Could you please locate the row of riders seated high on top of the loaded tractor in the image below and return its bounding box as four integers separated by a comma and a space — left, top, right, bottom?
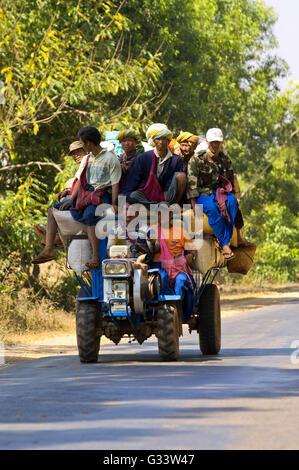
33, 124, 243, 269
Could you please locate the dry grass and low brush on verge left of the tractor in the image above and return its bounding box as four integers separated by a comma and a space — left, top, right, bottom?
0, 262, 78, 343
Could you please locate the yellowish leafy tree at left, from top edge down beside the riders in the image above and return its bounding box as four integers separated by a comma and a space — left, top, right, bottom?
0, 0, 164, 288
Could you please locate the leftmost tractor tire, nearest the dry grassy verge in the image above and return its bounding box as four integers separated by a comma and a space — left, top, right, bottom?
76, 294, 101, 362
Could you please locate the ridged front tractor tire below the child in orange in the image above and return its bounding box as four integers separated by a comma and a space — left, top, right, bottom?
157, 305, 179, 361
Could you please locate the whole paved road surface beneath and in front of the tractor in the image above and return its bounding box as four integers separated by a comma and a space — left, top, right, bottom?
0, 301, 299, 450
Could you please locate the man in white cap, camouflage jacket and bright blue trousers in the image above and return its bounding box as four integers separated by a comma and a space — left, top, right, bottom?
187, 128, 239, 260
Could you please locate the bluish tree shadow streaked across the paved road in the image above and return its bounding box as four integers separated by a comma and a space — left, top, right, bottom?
0, 342, 299, 449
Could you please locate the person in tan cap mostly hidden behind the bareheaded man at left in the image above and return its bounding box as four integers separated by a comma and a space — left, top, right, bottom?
33, 140, 87, 246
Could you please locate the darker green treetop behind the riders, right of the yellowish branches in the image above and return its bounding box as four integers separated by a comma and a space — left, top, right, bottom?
124, 0, 288, 176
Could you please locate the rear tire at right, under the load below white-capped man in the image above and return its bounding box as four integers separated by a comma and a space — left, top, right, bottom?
198, 284, 221, 355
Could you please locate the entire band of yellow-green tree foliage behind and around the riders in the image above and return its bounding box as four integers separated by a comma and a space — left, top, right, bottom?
0, 0, 298, 288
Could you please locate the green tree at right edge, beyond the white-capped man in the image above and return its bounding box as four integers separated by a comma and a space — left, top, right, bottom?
242, 85, 299, 281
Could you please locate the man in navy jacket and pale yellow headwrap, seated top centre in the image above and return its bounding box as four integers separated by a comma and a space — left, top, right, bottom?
122, 123, 187, 205
